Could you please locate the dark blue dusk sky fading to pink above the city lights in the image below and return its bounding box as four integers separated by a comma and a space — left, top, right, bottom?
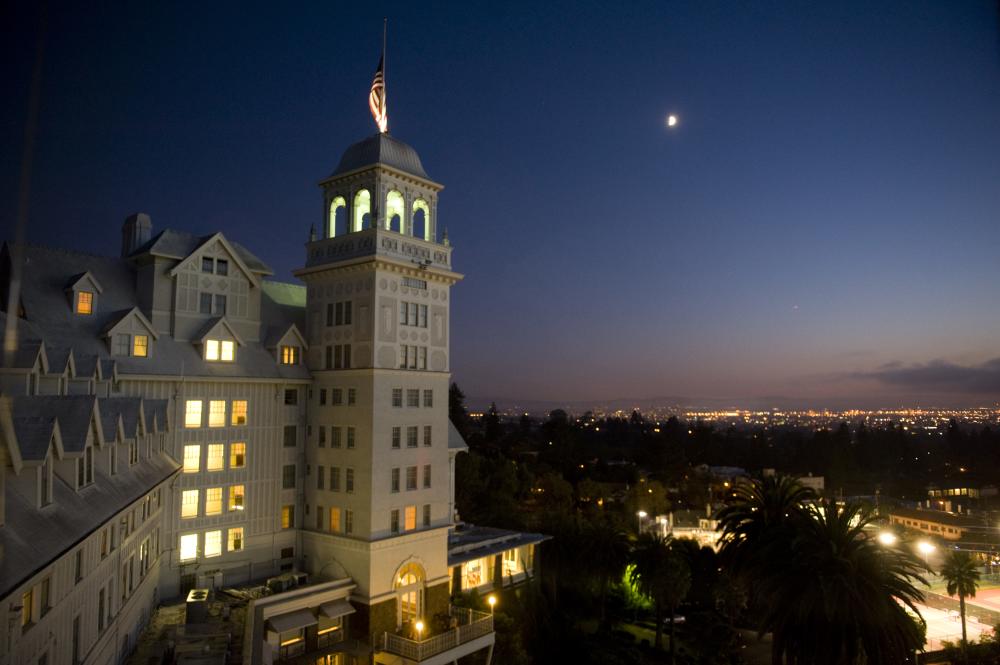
0, 0, 1000, 406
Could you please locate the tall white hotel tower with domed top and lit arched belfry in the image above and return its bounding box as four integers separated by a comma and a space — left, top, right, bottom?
295, 133, 462, 637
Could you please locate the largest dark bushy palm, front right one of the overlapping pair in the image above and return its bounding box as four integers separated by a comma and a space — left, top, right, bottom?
761, 504, 926, 665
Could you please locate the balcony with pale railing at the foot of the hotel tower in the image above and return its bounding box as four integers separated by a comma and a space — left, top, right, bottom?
375, 607, 494, 665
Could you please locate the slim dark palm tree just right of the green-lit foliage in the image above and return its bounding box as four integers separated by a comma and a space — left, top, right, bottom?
631, 533, 691, 663
